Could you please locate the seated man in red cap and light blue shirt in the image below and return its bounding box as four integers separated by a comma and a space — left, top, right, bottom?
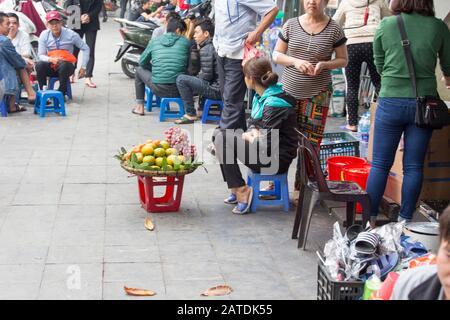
36, 11, 89, 96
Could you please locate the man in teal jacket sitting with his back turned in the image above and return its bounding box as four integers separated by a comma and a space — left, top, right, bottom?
132, 19, 191, 115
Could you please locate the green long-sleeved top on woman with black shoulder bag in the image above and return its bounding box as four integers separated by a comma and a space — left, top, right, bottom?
373, 13, 450, 98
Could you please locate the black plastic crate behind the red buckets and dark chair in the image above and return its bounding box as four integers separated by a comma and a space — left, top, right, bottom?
319, 132, 359, 172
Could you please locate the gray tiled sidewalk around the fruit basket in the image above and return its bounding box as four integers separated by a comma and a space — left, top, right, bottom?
0, 20, 334, 299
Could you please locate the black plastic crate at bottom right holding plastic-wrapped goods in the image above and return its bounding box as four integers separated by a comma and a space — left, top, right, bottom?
317, 255, 364, 300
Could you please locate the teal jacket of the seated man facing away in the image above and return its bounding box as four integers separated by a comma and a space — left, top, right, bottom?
139, 32, 191, 84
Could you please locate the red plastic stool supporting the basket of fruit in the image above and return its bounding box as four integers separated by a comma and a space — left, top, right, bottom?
138, 176, 184, 212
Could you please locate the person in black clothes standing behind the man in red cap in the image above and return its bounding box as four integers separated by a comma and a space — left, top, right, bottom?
65, 0, 103, 88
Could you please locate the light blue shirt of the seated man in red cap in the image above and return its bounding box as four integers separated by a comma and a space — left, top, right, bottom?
38, 28, 89, 68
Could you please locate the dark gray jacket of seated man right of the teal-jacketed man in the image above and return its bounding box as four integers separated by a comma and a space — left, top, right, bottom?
197, 39, 219, 88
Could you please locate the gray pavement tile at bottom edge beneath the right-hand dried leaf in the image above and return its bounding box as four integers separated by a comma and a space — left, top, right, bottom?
166, 280, 231, 300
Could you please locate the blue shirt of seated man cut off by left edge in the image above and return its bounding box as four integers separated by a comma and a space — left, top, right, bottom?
0, 35, 26, 95
